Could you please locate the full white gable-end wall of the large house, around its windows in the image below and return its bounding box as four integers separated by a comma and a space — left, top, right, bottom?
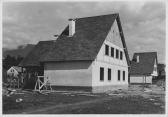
92, 19, 128, 86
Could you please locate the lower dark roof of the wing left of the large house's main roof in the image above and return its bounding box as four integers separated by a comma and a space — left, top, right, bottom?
19, 40, 54, 67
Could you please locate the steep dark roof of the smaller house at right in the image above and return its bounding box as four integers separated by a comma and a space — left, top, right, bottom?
130, 52, 157, 75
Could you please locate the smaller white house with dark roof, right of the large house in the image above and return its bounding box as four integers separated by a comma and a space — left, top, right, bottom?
130, 52, 158, 84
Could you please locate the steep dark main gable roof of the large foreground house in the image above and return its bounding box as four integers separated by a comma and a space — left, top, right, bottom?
19, 14, 129, 65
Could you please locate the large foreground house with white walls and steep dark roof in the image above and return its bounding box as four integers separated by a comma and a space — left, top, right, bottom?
20, 14, 129, 92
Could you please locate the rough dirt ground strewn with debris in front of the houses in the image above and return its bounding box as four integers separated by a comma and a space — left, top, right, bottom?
3, 85, 165, 114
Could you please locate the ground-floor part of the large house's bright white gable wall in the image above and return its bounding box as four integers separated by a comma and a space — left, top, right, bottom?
92, 61, 128, 86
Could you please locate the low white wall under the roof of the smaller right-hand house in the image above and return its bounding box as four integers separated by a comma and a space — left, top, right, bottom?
130, 75, 152, 84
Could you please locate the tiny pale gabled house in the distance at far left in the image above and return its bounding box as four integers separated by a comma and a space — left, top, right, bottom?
7, 66, 22, 78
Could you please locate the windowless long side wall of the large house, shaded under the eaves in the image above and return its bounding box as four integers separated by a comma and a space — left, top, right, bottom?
44, 61, 92, 86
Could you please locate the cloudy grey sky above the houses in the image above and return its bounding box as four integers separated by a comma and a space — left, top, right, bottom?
2, 1, 166, 63
